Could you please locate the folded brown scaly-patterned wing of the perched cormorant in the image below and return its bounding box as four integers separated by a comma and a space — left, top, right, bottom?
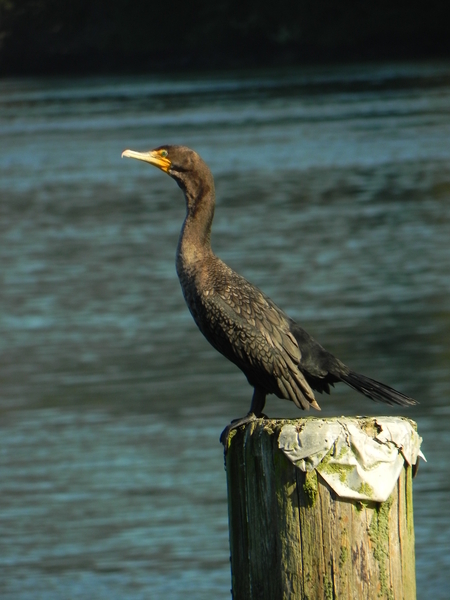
199, 278, 319, 409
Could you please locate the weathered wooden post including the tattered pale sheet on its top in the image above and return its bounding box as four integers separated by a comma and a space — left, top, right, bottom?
226, 417, 421, 600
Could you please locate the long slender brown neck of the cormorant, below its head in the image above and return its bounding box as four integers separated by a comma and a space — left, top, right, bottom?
177, 184, 215, 275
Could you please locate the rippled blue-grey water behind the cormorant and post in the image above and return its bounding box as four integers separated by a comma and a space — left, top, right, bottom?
0, 63, 450, 600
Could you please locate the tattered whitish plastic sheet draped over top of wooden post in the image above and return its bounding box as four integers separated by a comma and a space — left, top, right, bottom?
278, 417, 425, 502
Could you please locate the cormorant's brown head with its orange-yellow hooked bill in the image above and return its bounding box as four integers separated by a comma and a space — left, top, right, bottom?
122, 145, 213, 196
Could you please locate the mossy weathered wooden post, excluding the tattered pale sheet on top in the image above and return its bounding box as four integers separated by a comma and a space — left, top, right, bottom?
226, 418, 416, 600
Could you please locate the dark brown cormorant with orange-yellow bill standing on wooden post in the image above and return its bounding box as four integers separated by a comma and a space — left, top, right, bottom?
122, 145, 417, 448
